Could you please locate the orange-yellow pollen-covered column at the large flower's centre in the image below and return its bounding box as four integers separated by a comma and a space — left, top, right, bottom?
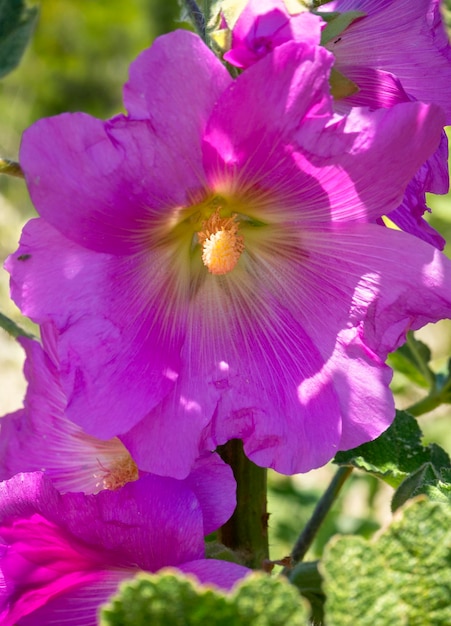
197, 208, 244, 274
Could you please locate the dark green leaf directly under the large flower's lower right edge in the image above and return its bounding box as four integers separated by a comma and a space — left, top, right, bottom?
334, 411, 451, 488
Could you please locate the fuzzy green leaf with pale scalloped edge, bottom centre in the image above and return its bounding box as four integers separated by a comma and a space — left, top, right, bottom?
100, 570, 308, 626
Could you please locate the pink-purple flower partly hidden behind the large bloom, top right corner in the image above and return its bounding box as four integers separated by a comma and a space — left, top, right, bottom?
320, 0, 451, 249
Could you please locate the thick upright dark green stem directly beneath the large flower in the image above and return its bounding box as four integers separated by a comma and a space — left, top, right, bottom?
218, 439, 269, 569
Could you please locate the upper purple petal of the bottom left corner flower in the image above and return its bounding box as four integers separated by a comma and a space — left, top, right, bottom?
0, 473, 204, 572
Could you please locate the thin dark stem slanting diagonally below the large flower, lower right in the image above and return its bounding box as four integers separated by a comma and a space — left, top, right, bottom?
282, 466, 353, 574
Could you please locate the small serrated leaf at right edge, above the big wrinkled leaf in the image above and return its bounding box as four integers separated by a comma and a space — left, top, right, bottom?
392, 462, 451, 511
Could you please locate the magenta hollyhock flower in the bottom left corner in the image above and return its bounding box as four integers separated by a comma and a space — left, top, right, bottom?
0, 472, 249, 626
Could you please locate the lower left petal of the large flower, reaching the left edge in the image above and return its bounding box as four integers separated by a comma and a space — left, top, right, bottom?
6, 219, 184, 439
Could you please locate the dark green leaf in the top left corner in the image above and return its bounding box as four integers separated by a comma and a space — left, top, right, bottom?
0, 0, 38, 78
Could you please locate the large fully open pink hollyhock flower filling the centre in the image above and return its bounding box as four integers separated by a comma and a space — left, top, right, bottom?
7, 31, 451, 478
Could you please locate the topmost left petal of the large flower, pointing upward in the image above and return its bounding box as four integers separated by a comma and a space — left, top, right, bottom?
124, 30, 232, 131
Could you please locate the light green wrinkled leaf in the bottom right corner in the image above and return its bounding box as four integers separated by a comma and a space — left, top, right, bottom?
322, 500, 451, 626
